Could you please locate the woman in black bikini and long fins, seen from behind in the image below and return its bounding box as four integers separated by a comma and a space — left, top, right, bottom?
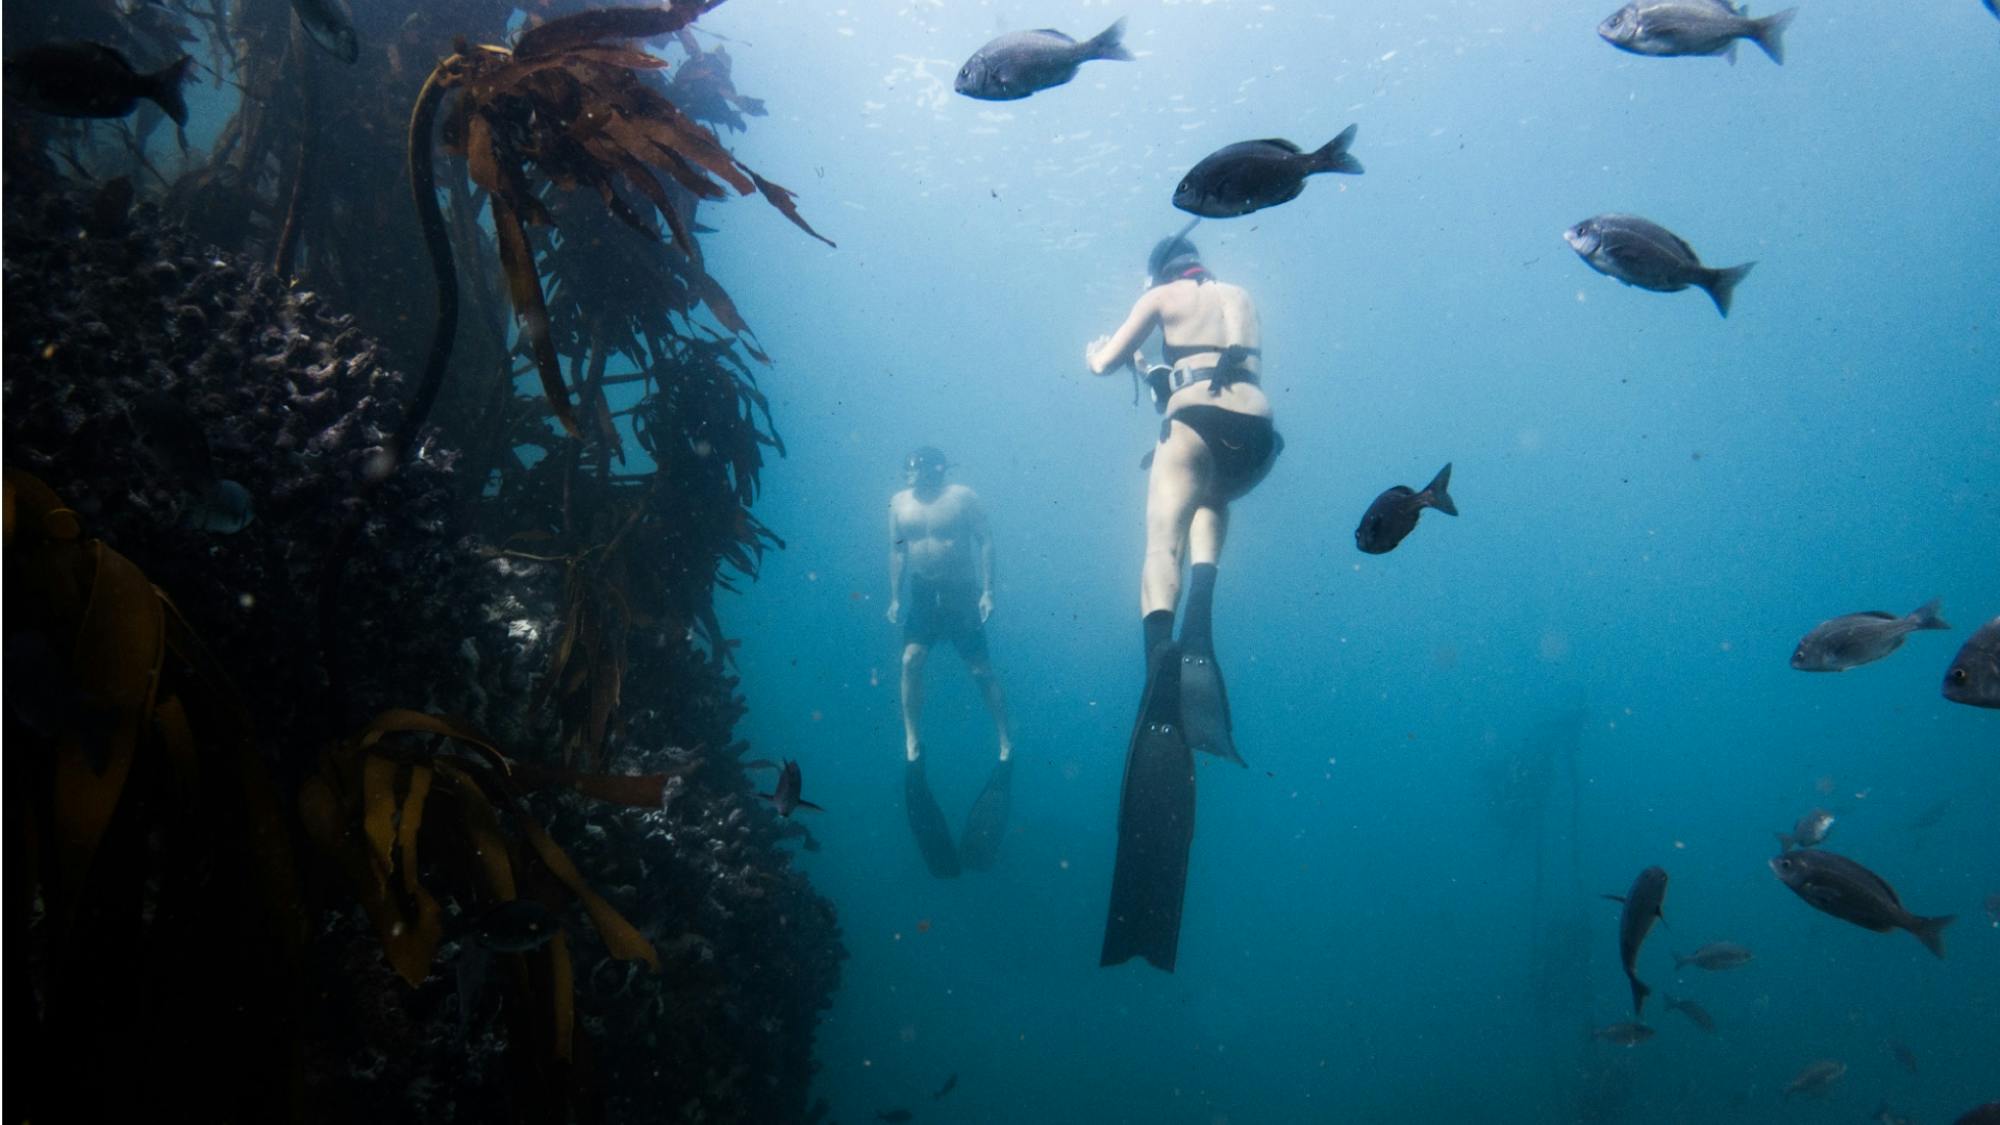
1084, 222, 1284, 973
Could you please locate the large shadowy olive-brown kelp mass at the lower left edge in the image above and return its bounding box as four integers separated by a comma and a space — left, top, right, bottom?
4, 468, 304, 1119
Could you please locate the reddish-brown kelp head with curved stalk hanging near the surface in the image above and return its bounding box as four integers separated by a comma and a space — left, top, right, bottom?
408, 0, 830, 436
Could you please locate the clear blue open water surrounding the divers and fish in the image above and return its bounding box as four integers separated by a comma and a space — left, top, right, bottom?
680, 0, 2000, 1123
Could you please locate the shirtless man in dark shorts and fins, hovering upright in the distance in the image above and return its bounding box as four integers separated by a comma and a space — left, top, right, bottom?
888, 446, 1014, 879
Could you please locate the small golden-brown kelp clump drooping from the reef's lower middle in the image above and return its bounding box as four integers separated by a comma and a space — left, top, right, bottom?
300, 711, 664, 984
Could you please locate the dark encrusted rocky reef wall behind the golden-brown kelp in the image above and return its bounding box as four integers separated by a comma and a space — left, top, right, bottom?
4, 182, 844, 1123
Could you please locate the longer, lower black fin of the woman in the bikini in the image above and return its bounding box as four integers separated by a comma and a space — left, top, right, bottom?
1098, 643, 1194, 973
